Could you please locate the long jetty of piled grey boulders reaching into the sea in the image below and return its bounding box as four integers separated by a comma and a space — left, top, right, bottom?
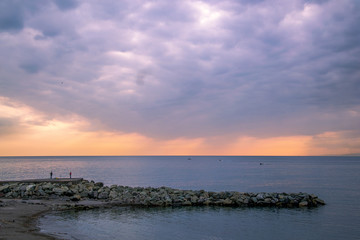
0, 180, 325, 208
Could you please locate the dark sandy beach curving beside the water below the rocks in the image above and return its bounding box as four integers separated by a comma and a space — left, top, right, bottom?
0, 199, 57, 240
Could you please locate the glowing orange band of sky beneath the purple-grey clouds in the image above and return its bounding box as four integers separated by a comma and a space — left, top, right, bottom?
0, 98, 360, 156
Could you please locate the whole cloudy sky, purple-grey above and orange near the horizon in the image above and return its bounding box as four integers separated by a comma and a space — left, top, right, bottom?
0, 0, 360, 156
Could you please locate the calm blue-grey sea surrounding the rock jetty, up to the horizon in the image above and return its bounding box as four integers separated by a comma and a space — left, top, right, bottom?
0, 156, 360, 240
